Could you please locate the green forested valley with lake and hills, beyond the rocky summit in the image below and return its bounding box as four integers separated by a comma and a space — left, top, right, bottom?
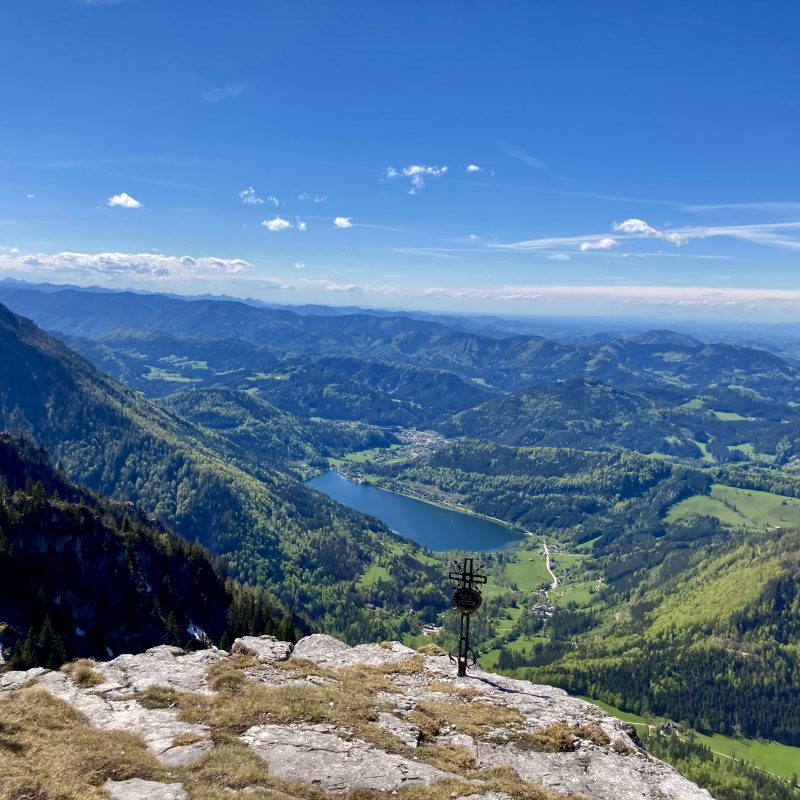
0, 285, 800, 800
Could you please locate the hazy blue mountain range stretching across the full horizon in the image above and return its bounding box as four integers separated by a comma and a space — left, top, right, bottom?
0, 286, 800, 402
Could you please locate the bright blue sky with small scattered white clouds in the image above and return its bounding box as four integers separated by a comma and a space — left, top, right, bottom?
0, 0, 800, 321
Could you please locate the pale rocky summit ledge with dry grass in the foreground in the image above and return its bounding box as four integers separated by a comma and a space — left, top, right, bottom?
0, 635, 710, 800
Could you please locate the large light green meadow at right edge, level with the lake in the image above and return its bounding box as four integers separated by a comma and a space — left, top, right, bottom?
667, 483, 800, 528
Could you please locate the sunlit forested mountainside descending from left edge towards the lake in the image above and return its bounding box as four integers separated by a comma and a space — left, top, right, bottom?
0, 306, 445, 638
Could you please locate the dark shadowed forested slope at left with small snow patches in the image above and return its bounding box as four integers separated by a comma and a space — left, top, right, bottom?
0, 434, 292, 669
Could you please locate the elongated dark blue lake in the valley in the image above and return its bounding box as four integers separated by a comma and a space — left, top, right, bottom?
306, 470, 525, 553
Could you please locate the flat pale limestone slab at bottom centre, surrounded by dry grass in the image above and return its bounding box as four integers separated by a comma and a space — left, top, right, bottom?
241, 725, 447, 792
